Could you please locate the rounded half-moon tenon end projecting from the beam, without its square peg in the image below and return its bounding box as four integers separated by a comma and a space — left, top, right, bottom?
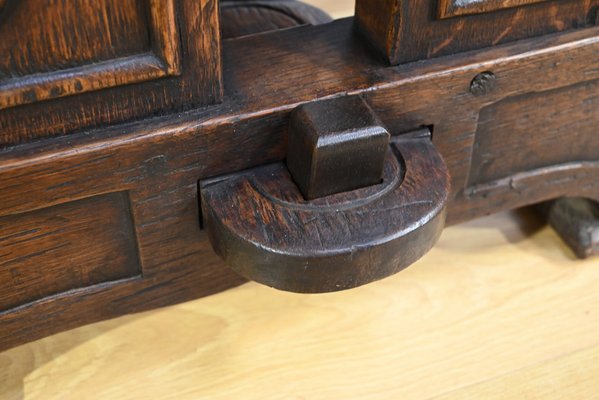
201, 131, 449, 293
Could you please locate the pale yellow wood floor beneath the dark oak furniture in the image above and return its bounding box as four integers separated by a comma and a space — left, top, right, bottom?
0, 212, 599, 400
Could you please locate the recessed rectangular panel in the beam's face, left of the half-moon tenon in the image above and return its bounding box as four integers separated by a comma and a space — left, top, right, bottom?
0, 193, 141, 312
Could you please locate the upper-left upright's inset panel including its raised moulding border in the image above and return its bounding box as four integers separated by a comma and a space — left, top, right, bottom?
0, 0, 180, 109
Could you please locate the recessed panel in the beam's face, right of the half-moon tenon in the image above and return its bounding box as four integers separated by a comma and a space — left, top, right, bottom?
470, 81, 599, 185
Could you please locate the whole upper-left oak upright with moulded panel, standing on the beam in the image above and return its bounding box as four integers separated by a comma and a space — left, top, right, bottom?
0, 0, 222, 146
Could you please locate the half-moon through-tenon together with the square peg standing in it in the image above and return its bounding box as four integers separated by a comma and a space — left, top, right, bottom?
200, 96, 449, 293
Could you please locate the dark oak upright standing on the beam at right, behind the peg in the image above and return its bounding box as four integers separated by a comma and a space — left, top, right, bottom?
356, 0, 599, 65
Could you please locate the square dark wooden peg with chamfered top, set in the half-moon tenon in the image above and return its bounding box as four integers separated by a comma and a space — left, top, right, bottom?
287, 96, 390, 200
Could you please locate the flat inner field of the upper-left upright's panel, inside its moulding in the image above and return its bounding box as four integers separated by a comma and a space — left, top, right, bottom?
0, 0, 150, 76
